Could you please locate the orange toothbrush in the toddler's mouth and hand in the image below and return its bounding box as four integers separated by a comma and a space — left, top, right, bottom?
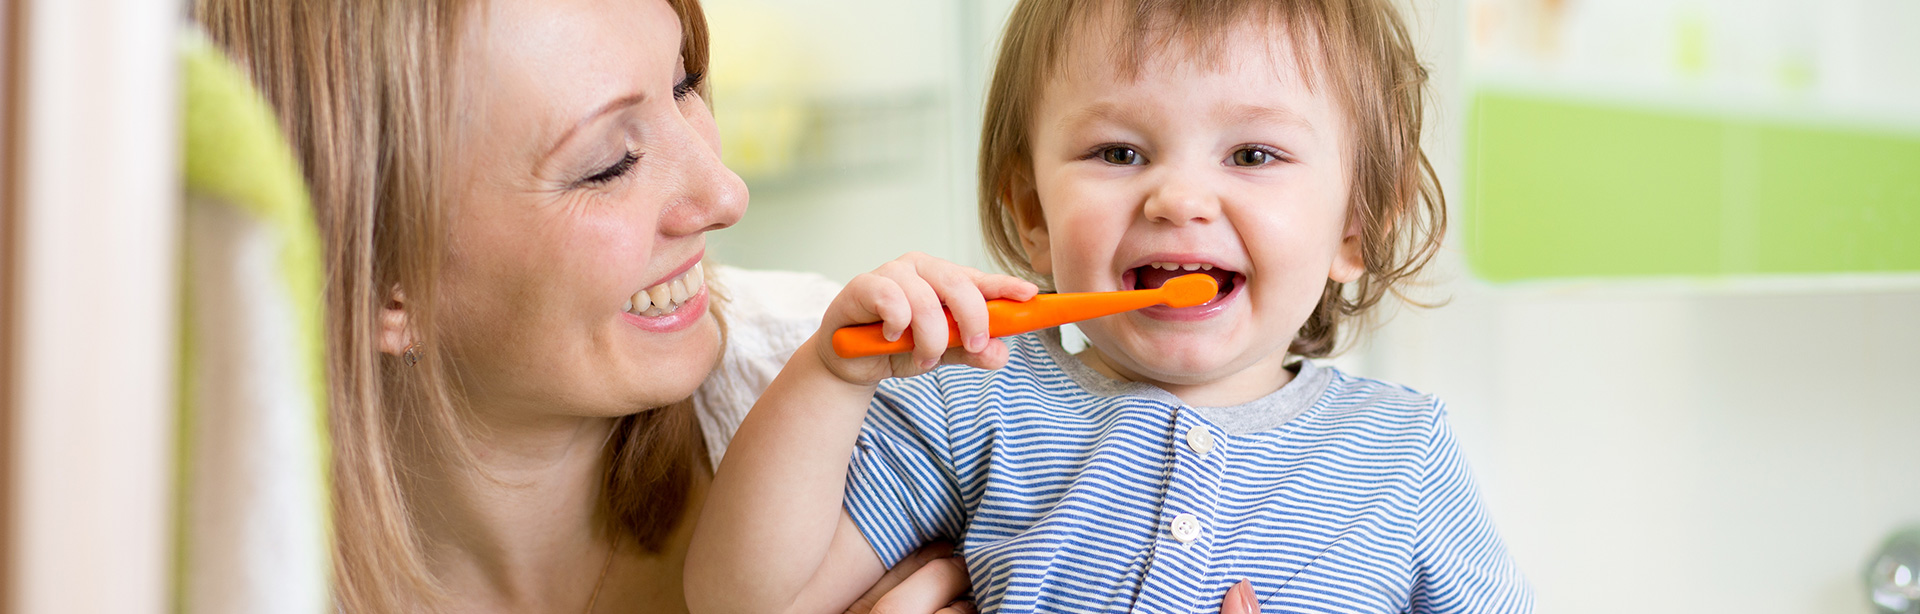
833, 272, 1219, 359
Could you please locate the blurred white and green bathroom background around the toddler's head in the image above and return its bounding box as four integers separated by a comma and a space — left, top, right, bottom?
708, 0, 1920, 614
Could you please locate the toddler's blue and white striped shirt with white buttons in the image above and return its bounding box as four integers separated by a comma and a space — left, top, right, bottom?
847, 330, 1532, 614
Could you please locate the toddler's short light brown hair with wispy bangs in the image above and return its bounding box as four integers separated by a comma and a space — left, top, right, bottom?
979, 0, 1446, 357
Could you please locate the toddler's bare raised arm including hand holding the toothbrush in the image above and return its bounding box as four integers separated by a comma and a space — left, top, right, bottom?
685, 253, 1039, 614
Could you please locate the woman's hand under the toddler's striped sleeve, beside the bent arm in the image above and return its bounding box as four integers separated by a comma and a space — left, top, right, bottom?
847, 543, 975, 614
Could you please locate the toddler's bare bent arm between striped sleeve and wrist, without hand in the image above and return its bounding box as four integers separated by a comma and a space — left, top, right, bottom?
685, 336, 881, 614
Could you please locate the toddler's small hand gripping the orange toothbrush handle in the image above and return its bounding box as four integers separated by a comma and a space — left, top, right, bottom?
814, 251, 1041, 386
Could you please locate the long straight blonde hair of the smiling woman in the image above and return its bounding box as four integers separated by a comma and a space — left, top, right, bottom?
194, 0, 722, 612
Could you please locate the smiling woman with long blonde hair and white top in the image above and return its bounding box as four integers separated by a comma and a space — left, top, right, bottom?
196, 0, 966, 612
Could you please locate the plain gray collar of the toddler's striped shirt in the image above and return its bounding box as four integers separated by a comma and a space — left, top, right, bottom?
1041, 328, 1332, 436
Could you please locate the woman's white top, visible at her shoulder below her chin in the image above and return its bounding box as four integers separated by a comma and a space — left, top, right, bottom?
693, 267, 841, 468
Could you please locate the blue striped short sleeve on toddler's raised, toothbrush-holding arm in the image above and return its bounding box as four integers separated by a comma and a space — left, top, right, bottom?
847, 366, 966, 568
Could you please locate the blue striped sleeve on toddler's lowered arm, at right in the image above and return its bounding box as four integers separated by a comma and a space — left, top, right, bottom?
1409, 407, 1534, 612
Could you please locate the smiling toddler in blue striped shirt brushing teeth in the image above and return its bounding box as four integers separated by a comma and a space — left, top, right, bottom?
687, 0, 1532, 612
